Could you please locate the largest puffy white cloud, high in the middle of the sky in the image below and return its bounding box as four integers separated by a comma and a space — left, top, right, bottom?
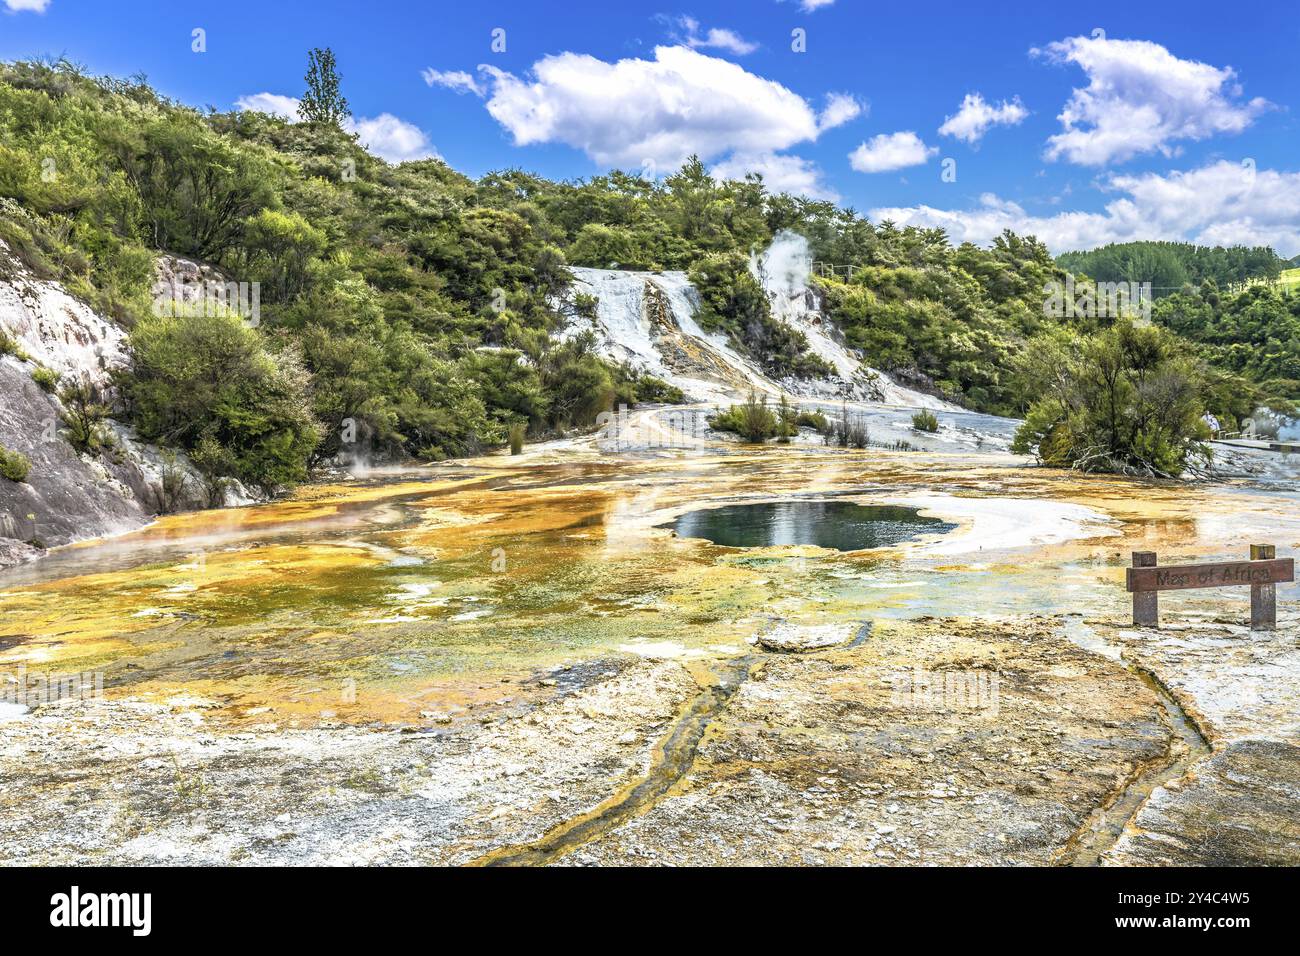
478, 46, 850, 169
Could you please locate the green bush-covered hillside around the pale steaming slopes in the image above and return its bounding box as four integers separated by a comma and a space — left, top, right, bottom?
0, 55, 1300, 485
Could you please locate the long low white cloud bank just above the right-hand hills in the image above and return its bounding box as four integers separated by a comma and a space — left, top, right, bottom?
870, 160, 1300, 258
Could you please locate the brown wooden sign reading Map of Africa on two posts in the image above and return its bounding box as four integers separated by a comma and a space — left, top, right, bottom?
1126, 545, 1295, 631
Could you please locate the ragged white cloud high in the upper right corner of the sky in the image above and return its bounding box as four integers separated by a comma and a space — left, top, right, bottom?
1030, 36, 1270, 166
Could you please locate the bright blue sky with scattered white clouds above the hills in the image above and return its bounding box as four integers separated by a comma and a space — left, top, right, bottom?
0, 0, 1300, 256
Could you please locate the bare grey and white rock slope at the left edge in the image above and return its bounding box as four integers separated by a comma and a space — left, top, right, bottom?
0, 242, 252, 567
